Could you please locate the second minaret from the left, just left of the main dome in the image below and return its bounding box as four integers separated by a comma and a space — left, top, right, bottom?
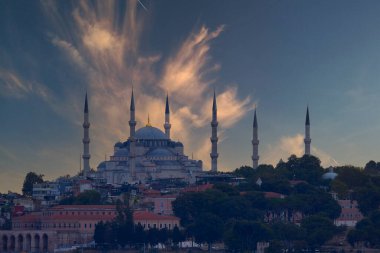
129, 88, 136, 180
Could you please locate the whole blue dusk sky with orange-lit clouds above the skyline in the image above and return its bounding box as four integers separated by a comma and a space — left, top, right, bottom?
0, 0, 380, 192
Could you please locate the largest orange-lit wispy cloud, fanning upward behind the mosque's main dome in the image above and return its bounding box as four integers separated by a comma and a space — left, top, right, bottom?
37, 0, 252, 170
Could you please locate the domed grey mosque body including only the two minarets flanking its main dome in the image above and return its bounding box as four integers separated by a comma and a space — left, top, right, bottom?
94, 91, 202, 184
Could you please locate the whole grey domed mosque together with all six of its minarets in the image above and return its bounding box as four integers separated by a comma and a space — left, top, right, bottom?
82, 90, 311, 184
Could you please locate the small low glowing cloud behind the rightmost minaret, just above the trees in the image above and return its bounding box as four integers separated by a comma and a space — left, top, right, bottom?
261, 133, 339, 167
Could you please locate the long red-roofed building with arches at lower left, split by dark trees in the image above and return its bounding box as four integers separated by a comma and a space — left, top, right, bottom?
0, 205, 179, 252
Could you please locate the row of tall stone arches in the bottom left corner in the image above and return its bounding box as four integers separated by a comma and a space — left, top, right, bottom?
0, 230, 56, 252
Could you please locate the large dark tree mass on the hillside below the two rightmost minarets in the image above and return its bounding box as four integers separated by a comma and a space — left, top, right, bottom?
173, 156, 341, 252
